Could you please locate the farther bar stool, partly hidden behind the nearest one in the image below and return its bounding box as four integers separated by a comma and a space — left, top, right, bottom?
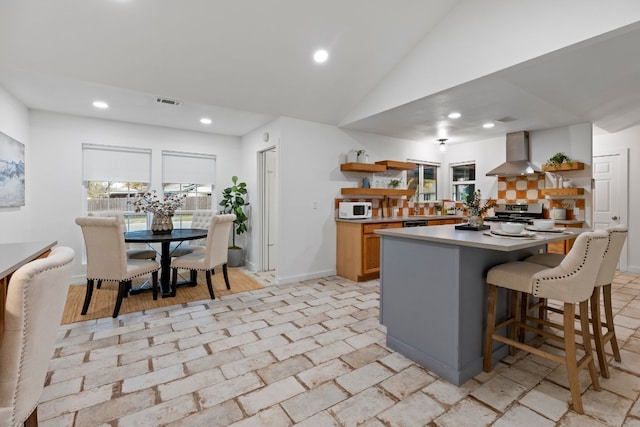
525, 225, 628, 378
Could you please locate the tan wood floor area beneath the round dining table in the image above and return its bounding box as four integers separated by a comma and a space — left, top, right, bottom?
61, 268, 262, 325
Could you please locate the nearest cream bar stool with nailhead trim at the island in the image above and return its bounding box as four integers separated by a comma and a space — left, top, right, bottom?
484, 231, 608, 414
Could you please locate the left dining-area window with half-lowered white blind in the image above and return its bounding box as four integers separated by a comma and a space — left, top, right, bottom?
82, 144, 151, 231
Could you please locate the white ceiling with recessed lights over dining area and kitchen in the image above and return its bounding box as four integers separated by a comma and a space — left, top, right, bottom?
0, 0, 640, 142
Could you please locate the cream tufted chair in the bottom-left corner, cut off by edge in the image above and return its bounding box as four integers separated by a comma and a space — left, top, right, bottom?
0, 246, 74, 427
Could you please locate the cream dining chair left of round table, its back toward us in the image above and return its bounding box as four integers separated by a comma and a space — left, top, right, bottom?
76, 216, 160, 318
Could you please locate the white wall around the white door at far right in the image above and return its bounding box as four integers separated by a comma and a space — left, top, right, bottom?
593, 125, 640, 273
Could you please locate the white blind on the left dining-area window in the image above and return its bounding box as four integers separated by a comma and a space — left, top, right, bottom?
82, 144, 151, 182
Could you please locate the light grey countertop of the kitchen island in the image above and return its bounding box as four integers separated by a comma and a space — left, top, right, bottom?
375, 225, 585, 252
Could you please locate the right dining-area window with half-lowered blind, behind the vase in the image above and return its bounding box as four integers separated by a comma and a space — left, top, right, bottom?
162, 150, 217, 228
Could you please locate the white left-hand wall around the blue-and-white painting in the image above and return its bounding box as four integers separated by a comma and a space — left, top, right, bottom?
0, 86, 34, 243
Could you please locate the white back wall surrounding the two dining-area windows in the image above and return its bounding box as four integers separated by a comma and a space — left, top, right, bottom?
26, 111, 242, 280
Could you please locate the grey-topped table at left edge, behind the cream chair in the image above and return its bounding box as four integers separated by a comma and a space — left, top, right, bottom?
0, 240, 58, 346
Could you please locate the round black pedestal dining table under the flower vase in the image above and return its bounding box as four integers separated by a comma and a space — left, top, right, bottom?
124, 228, 209, 298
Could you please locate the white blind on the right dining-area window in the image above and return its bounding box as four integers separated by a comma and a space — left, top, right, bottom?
162, 150, 216, 185
